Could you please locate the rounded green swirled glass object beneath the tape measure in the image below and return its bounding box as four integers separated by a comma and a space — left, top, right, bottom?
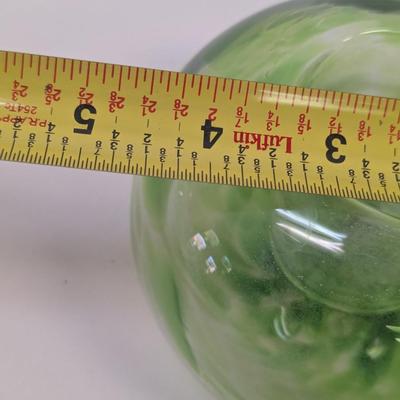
132, 0, 400, 400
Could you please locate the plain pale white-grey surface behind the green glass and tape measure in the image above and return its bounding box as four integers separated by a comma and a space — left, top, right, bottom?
0, 0, 279, 400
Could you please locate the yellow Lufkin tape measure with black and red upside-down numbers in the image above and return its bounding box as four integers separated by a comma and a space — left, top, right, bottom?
0, 52, 400, 202
